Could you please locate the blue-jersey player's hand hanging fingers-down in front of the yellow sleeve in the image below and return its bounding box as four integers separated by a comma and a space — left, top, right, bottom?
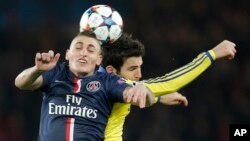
124, 84, 154, 108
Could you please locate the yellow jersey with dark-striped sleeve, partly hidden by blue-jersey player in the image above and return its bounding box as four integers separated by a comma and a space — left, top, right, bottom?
104, 50, 216, 141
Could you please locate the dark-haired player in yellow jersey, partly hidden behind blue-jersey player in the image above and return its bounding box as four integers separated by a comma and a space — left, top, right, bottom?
98, 33, 236, 141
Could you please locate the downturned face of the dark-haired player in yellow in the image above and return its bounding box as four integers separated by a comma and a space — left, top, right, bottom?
118, 57, 143, 81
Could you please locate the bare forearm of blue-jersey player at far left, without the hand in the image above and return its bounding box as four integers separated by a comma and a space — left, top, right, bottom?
15, 66, 42, 90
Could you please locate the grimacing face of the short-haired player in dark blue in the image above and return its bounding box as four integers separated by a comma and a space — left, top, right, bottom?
66, 36, 102, 77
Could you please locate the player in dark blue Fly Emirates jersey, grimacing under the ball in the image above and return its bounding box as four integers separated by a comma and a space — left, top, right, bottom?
15, 31, 154, 141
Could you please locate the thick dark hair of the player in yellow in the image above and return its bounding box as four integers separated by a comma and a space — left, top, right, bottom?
102, 33, 145, 72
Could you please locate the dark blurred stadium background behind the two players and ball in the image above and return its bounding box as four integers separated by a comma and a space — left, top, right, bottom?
0, 0, 250, 141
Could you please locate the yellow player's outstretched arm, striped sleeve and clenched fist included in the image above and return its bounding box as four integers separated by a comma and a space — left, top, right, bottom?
143, 40, 236, 96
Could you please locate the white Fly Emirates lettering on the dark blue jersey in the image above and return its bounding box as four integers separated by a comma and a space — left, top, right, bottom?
49, 95, 98, 119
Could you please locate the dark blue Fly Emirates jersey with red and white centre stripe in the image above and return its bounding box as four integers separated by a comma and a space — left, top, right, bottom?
39, 63, 128, 141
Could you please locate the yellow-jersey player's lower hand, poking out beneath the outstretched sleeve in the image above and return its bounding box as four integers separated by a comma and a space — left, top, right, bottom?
160, 92, 188, 106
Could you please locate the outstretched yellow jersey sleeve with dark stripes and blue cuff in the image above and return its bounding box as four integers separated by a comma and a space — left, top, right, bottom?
142, 50, 216, 96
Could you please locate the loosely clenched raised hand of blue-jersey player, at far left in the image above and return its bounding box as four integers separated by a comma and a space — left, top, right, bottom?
35, 50, 60, 72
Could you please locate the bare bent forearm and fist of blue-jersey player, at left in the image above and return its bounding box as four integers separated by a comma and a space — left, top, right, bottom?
15, 50, 60, 90
